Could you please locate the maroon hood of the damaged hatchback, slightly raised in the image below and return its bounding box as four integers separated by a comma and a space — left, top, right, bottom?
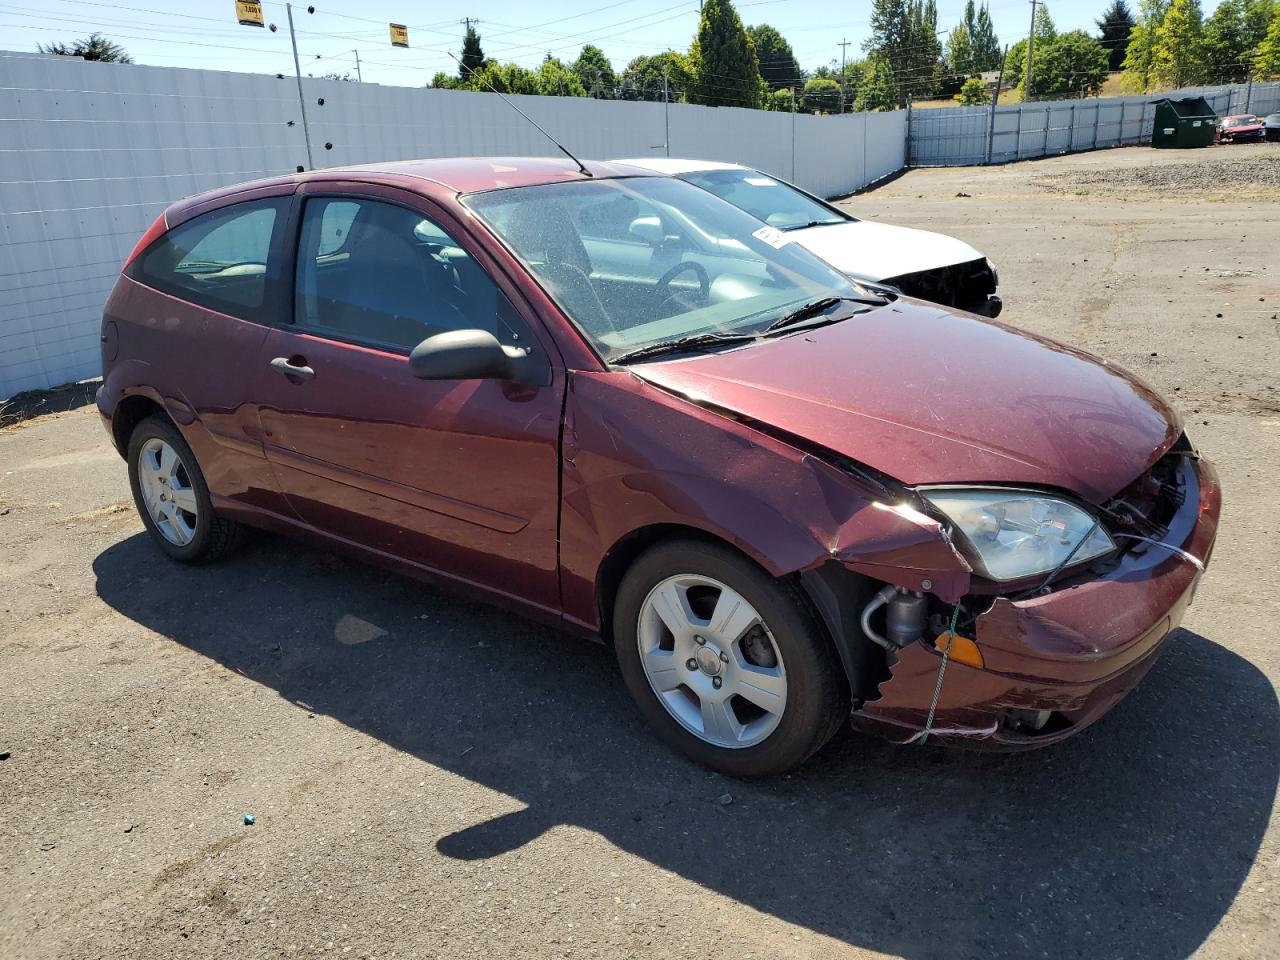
628, 300, 1181, 503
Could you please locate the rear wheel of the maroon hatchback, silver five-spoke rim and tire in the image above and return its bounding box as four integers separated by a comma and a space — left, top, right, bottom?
128, 416, 242, 563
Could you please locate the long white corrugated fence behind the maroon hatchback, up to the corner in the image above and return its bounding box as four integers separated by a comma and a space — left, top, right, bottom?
0, 54, 906, 398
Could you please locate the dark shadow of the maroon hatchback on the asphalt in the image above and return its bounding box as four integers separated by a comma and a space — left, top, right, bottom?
93, 534, 1280, 960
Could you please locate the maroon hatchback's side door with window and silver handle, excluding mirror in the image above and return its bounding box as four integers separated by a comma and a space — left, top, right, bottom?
256, 183, 564, 609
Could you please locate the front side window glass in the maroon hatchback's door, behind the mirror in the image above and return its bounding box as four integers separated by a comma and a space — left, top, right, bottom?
293, 197, 525, 353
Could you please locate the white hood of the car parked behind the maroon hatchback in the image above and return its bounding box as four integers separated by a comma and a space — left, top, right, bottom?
783, 220, 982, 280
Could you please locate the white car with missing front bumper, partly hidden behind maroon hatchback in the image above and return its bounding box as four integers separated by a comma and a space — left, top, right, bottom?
616, 157, 1001, 317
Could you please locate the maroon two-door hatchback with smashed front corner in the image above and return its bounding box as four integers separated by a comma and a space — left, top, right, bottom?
99, 159, 1220, 776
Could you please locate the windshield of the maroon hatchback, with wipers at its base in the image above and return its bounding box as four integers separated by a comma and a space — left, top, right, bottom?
463, 177, 867, 360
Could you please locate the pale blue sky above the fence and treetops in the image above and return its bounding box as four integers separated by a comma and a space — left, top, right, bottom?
0, 0, 1216, 86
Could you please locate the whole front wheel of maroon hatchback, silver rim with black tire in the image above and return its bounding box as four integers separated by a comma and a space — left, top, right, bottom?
613, 540, 849, 777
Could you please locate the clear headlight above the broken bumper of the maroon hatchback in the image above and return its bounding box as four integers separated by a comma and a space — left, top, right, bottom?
919, 488, 1115, 581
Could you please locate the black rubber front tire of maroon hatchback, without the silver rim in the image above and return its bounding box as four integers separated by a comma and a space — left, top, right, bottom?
613, 540, 850, 777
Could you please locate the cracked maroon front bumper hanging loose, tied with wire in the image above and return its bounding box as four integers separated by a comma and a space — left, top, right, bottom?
851, 458, 1221, 749
